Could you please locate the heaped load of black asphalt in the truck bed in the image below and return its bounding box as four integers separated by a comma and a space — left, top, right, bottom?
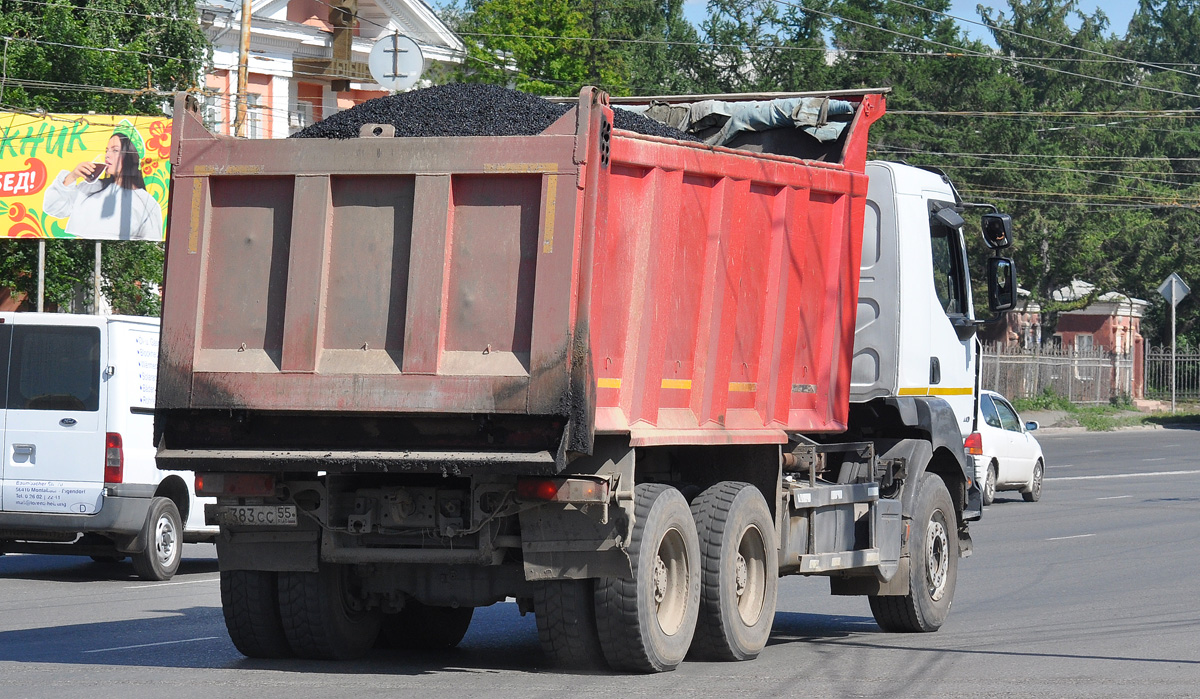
292, 83, 697, 141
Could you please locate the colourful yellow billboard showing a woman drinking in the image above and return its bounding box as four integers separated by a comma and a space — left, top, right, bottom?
0, 112, 170, 241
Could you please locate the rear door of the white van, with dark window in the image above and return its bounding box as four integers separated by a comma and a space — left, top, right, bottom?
0, 316, 107, 514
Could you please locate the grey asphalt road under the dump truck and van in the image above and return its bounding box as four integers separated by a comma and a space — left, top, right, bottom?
0, 430, 1200, 699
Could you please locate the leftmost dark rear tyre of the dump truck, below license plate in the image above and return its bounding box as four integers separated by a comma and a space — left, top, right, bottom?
221, 570, 292, 658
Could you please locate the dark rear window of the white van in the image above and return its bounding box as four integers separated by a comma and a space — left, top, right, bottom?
6, 325, 100, 412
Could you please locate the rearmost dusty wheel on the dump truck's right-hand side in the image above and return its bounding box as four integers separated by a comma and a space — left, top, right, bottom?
595, 483, 700, 673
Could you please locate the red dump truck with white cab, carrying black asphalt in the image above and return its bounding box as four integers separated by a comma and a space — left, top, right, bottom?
155, 88, 1015, 671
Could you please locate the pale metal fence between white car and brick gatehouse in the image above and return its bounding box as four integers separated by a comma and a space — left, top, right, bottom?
980, 346, 1132, 405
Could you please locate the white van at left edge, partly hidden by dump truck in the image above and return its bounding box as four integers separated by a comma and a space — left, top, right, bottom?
0, 312, 218, 580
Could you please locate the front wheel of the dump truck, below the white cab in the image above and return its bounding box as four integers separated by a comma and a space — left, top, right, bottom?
870, 473, 959, 632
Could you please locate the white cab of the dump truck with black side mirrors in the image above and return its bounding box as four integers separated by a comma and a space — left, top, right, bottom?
851, 161, 1015, 519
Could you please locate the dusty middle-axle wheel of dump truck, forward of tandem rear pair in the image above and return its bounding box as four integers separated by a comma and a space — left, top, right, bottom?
691, 482, 779, 661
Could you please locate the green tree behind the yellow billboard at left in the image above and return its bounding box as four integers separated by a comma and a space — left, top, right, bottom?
0, 0, 210, 315
